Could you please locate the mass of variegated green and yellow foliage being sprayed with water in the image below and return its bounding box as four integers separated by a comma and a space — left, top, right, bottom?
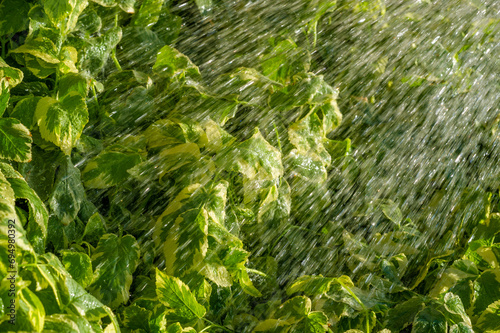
0, 0, 500, 333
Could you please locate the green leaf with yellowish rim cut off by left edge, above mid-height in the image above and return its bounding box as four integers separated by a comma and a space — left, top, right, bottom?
0, 118, 32, 162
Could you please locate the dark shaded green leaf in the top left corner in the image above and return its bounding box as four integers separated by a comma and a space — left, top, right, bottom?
0, 0, 30, 36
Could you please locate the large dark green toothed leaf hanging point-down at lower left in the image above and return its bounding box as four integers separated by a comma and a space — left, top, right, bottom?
88, 234, 140, 308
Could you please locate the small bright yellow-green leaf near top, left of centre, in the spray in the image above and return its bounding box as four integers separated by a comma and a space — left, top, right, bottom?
153, 45, 200, 78
